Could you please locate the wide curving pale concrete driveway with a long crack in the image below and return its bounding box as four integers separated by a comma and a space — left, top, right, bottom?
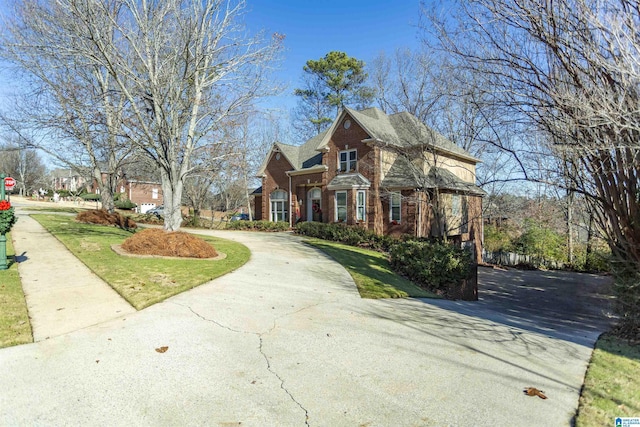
0, 232, 607, 426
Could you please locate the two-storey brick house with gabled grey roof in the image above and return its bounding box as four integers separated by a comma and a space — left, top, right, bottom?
256, 107, 485, 260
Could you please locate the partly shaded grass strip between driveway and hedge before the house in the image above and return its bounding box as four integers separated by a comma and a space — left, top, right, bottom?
305, 238, 439, 298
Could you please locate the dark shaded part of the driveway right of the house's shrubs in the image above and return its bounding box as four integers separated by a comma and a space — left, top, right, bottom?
360, 267, 615, 347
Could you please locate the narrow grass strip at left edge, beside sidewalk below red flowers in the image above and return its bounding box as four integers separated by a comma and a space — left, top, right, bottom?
0, 234, 33, 348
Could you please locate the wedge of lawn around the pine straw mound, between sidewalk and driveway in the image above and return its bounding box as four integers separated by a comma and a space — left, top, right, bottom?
33, 214, 251, 310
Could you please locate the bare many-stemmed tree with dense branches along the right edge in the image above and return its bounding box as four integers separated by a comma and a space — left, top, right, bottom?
430, 0, 640, 335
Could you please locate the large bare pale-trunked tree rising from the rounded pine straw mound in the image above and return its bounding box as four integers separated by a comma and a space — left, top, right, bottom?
1, 0, 284, 230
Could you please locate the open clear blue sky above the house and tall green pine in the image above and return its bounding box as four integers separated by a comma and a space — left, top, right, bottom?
245, 0, 420, 110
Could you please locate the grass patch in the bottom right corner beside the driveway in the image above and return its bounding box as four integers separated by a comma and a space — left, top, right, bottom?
576, 335, 640, 427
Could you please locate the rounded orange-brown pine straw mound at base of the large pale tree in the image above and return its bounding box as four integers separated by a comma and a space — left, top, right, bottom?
121, 228, 218, 258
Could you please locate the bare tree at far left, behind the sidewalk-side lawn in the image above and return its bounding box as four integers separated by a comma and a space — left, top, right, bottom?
0, 1, 132, 211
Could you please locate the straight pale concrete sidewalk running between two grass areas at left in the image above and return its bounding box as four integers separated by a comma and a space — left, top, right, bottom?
12, 207, 136, 341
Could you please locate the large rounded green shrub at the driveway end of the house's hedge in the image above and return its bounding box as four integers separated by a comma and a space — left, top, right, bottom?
390, 240, 471, 293
